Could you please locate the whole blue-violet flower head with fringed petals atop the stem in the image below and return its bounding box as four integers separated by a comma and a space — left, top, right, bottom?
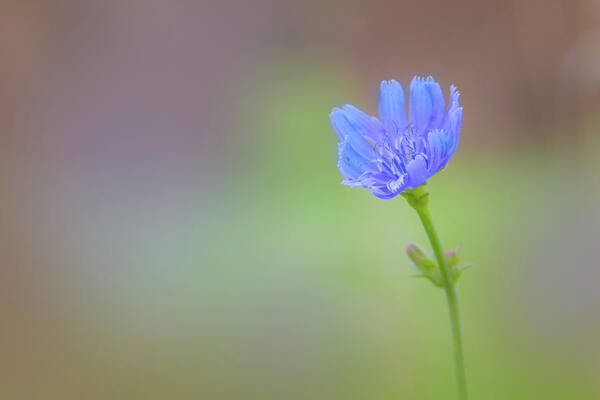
330, 76, 462, 199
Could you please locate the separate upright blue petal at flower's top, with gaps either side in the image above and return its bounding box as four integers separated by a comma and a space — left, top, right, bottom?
379, 79, 408, 137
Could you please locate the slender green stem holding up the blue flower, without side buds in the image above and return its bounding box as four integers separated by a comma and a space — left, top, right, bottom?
405, 186, 467, 400
